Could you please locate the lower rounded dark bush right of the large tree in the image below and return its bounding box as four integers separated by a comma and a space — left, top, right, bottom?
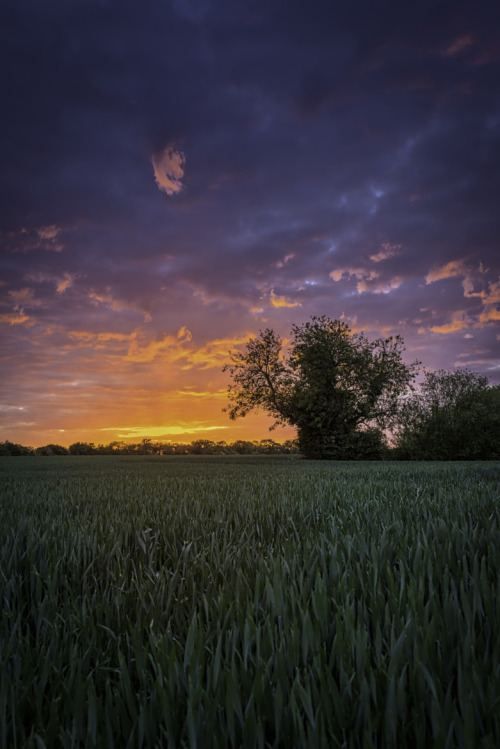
395, 369, 500, 460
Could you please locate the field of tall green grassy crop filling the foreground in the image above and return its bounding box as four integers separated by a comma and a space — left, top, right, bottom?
0, 456, 500, 749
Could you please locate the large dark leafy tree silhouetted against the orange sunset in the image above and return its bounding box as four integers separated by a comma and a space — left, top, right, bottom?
224, 316, 417, 458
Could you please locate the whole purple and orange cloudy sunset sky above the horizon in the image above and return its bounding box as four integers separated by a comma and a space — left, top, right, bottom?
0, 0, 500, 446
